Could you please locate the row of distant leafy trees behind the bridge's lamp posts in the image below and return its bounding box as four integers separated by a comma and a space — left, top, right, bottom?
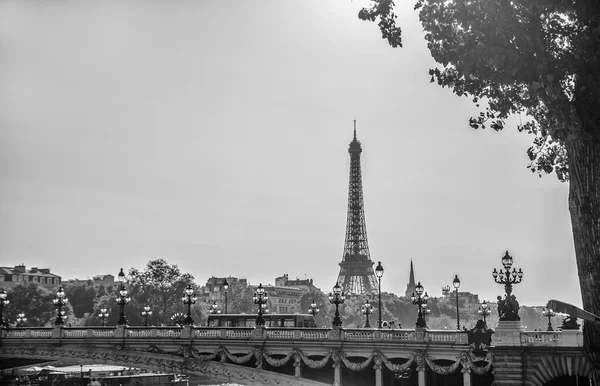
4, 259, 559, 330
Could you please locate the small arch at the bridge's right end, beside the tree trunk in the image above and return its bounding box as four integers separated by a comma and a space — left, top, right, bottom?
526, 355, 592, 386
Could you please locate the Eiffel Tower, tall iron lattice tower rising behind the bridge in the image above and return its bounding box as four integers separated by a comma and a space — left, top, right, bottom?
338, 120, 378, 294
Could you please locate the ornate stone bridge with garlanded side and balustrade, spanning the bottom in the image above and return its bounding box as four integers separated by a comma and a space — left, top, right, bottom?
0, 326, 591, 386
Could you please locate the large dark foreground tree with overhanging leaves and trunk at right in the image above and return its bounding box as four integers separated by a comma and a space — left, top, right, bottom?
358, 0, 600, 364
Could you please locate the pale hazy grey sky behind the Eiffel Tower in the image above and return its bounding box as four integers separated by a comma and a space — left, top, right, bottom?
0, 0, 581, 305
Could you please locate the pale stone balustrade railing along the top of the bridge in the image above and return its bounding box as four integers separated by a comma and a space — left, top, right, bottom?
0, 326, 583, 347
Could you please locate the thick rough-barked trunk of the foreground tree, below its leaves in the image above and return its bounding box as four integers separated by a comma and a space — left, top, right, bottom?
564, 138, 600, 382
